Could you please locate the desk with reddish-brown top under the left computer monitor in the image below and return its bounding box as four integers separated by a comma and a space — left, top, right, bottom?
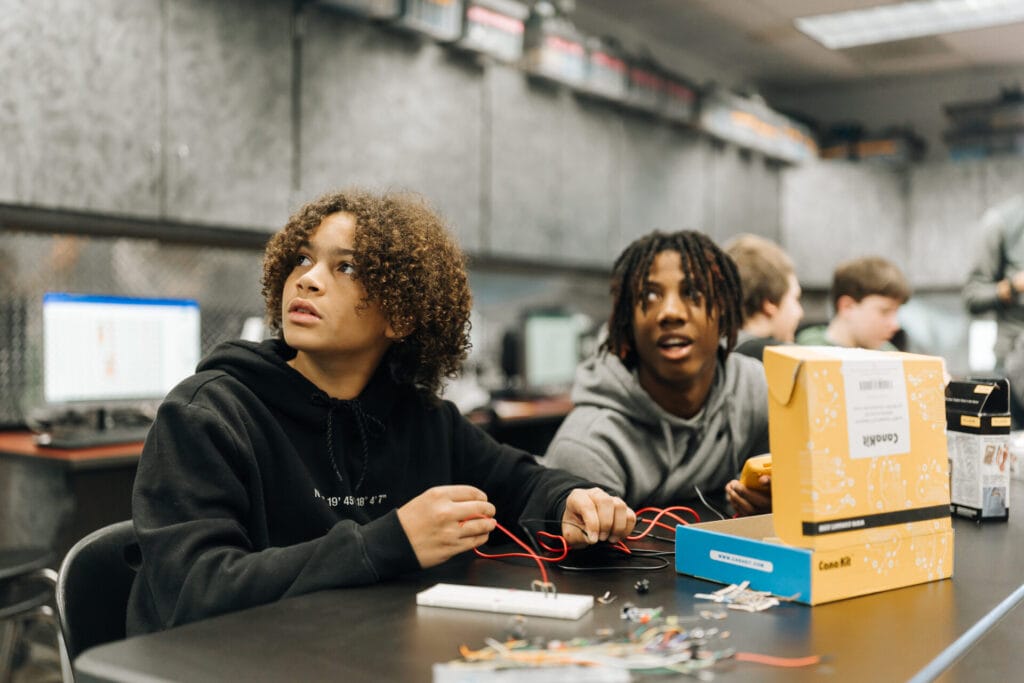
0, 431, 142, 558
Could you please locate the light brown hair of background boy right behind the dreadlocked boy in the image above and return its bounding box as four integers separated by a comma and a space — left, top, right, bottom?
725, 234, 795, 321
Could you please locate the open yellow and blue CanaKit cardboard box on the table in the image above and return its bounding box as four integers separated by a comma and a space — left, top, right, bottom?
676, 346, 953, 604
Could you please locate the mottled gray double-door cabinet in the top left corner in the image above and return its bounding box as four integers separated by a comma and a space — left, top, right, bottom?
0, 0, 292, 228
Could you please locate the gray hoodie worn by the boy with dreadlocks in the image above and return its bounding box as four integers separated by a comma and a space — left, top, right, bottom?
543, 351, 768, 509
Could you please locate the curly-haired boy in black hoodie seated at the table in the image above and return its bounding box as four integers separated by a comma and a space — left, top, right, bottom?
127, 190, 635, 634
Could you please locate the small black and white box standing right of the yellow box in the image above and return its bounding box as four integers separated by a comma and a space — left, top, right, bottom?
946, 378, 1012, 521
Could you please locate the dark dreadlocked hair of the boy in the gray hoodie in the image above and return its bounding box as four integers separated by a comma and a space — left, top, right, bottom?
602, 230, 743, 370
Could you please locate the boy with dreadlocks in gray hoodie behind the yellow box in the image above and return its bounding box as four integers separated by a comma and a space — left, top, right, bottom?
545, 230, 771, 514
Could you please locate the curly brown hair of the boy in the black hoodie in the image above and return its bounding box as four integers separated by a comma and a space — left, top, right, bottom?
262, 189, 472, 394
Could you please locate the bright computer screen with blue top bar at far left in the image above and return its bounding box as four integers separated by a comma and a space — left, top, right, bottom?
43, 293, 201, 403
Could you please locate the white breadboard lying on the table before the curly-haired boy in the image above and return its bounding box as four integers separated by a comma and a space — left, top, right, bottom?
416, 584, 594, 618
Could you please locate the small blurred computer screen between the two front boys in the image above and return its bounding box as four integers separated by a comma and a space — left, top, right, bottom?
520, 312, 580, 391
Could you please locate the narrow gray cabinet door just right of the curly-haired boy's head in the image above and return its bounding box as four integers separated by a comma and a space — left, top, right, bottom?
486, 67, 569, 260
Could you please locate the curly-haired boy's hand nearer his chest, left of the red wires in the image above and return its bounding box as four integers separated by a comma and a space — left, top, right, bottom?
398, 484, 496, 569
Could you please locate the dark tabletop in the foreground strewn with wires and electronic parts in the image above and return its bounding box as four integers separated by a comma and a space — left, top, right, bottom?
75, 493, 1024, 683
